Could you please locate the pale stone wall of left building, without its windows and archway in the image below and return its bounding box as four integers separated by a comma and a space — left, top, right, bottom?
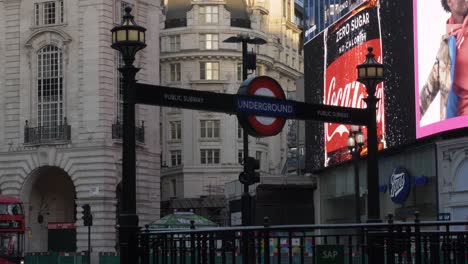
0, 0, 161, 257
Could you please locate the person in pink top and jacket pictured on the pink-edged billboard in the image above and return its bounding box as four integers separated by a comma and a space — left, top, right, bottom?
419, 0, 468, 120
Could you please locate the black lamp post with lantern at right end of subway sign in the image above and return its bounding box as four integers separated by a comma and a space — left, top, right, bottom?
357, 47, 384, 222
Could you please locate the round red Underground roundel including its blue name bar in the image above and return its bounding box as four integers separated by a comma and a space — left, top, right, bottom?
237, 76, 295, 137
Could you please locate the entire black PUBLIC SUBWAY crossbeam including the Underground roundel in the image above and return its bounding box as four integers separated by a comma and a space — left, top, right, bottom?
135, 81, 368, 137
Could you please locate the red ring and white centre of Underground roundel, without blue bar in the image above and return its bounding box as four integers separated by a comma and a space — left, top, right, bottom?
237, 76, 286, 137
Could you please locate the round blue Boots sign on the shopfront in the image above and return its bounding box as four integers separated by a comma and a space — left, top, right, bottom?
388, 167, 411, 204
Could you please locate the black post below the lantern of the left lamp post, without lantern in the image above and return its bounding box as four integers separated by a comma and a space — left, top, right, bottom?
119, 63, 140, 264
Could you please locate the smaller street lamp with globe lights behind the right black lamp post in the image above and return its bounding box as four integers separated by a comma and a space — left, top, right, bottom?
346, 125, 366, 223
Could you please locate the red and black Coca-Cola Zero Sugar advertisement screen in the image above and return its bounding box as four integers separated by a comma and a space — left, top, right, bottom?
323, 6, 385, 166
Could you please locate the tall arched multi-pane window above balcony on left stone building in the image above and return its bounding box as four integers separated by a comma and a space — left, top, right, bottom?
37, 45, 64, 139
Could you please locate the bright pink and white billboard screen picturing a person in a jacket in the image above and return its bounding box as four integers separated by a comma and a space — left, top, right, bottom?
413, 0, 468, 138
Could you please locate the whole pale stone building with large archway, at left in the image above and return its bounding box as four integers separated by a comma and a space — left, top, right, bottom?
0, 0, 160, 256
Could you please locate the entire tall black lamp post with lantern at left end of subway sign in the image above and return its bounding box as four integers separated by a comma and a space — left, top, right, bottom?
111, 6, 146, 264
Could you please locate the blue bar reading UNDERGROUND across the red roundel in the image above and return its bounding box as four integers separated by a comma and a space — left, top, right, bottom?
237, 98, 295, 117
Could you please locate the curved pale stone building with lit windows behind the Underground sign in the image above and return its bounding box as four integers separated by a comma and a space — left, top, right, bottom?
160, 0, 303, 224
